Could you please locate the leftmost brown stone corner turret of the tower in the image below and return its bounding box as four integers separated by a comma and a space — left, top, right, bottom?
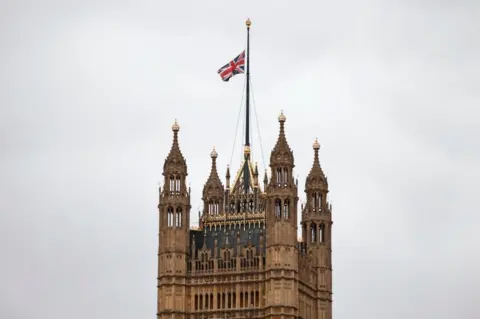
157, 121, 190, 318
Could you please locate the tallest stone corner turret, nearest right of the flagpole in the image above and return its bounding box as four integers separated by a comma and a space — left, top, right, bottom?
265, 112, 298, 318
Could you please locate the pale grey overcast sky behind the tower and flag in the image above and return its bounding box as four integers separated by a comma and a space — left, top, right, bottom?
0, 0, 480, 319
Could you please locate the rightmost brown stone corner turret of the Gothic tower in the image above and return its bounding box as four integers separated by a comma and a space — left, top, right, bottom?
302, 140, 332, 319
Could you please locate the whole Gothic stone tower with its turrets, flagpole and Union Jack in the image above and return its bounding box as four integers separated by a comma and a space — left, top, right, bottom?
157, 20, 332, 319
